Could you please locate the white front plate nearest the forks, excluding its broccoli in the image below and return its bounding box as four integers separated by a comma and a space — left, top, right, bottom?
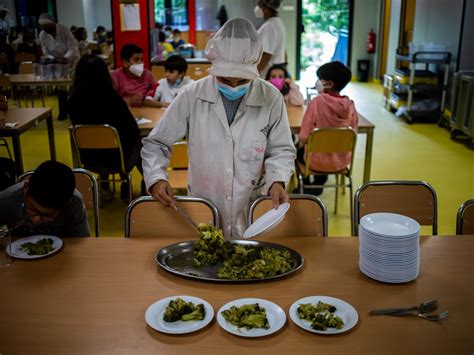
288, 296, 359, 334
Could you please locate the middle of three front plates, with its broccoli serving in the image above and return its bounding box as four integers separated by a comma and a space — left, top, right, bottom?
217, 298, 286, 337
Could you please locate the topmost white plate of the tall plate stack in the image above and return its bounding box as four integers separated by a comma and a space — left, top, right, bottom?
360, 213, 420, 237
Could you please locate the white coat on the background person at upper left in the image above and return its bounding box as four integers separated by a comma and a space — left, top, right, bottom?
39, 23, 80, 66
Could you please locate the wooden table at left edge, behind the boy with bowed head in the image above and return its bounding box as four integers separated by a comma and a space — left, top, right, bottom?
0, 108, 56, 174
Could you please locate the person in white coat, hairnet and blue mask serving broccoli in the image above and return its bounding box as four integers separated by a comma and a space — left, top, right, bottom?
142, 18, 295, 238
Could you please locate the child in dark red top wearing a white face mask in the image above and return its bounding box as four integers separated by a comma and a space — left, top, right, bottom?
111, 44, 156, 107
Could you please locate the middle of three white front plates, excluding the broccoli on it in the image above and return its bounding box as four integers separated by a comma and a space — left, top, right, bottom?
217, 298, 286, 337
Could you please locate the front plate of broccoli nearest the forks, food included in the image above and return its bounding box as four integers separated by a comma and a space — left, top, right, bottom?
288, 296, 359, 334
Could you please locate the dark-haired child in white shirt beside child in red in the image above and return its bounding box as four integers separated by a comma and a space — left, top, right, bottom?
146, 55, 194, 107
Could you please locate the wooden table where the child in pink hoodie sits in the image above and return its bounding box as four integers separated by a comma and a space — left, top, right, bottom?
286, 105, 375, 183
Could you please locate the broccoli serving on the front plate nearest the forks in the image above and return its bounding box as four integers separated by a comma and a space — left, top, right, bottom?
297, 301, 344, 330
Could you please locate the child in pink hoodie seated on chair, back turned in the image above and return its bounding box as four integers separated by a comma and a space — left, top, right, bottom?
297, 61, 359, 195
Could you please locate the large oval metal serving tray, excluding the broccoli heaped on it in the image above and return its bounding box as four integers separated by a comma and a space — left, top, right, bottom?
155, 240, 304, 283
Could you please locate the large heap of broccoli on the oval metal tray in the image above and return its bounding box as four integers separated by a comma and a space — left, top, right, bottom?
193, 223, 293, 280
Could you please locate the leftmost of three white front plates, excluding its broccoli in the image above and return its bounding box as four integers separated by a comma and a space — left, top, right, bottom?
145, 296, 214, 334
